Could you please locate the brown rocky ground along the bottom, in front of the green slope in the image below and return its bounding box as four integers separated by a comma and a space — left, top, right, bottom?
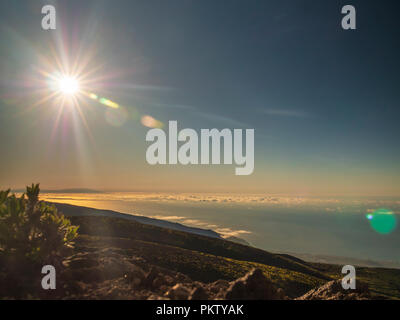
49, 248, 371, 300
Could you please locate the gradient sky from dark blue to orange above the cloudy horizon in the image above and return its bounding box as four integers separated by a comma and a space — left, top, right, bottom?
0, 0, 400, 196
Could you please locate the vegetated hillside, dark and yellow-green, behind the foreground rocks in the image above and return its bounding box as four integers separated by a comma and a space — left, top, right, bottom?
53, 205, 400, 298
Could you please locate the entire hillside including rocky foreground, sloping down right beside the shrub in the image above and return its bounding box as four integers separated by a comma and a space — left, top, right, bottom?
0, 204, 400, 300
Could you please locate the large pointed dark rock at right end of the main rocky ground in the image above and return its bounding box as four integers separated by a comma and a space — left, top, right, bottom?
225, 269, 283, 300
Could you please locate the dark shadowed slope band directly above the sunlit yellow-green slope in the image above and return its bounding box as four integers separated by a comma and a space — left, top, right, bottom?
70, 216, 330, 280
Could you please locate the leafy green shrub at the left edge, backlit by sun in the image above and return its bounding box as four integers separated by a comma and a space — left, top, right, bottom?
0, 184, 78, 294
